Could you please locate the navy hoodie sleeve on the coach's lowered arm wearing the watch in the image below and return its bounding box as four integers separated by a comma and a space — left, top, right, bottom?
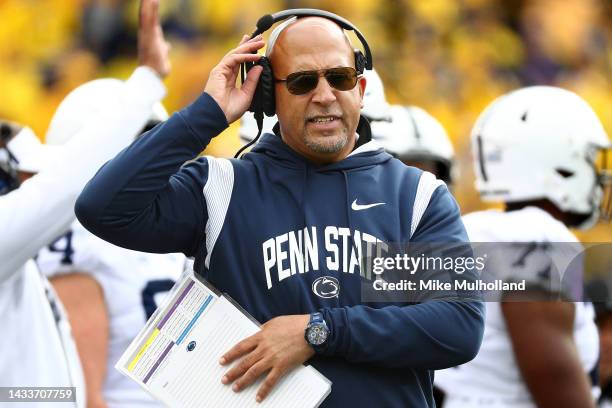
322, 187, 484, 370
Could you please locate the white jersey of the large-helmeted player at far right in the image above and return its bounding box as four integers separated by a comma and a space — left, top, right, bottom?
435, 207, 599, 408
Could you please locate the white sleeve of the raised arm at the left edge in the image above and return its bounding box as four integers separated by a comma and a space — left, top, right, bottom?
0, 67, 166, 282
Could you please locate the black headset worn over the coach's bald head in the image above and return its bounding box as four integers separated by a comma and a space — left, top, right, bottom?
234, 8, 373, 157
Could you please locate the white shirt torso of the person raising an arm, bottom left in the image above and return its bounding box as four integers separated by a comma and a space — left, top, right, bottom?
0, 260, 84, 408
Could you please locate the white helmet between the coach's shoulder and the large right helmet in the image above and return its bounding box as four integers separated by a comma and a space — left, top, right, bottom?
372, 105, 456, 184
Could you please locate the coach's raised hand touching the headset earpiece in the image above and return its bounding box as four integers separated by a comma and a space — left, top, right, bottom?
204, 35, 264, 123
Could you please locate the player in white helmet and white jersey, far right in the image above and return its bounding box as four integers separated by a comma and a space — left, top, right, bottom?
436, 86, 611, 408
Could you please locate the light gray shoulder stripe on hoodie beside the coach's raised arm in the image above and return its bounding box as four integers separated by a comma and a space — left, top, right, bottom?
203, 156, 234, 268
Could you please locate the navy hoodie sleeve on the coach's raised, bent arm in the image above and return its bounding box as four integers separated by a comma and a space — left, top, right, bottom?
75, 93, 228, 256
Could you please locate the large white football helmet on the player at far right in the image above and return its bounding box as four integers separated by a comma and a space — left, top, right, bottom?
472, 86, 612, 228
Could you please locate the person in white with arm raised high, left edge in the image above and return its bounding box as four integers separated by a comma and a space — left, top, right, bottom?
0, 2, 169, 406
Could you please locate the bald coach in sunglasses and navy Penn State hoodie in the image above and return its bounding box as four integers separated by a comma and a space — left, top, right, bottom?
76, 17, 483, 407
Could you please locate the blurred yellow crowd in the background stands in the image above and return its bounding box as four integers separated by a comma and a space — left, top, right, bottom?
0, 0, 612, 242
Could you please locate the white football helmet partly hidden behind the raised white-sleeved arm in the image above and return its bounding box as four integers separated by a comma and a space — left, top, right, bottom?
45, 78, 168, 145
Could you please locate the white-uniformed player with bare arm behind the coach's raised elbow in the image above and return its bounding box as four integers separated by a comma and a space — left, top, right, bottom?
26, 83, 185, 408
